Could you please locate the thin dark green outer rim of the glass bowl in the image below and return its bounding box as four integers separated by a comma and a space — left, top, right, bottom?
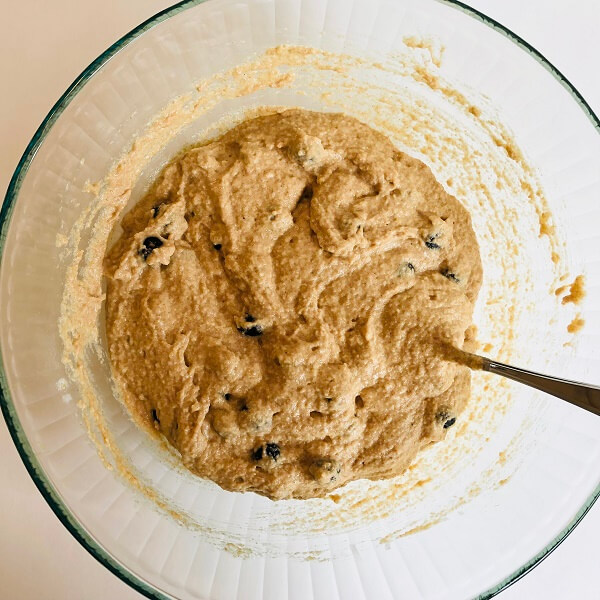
0, 0, 600, 600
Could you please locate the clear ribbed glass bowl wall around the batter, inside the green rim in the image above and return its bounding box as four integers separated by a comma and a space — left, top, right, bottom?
0, 0, 600, 600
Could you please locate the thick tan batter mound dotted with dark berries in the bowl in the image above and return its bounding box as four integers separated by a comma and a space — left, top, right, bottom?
105, 110, 482, 499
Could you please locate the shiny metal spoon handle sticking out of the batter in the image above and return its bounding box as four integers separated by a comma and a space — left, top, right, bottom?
479, 357, 600, 415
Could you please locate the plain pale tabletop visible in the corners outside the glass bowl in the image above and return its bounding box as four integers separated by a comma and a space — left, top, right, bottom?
0, 0, 600, 600
